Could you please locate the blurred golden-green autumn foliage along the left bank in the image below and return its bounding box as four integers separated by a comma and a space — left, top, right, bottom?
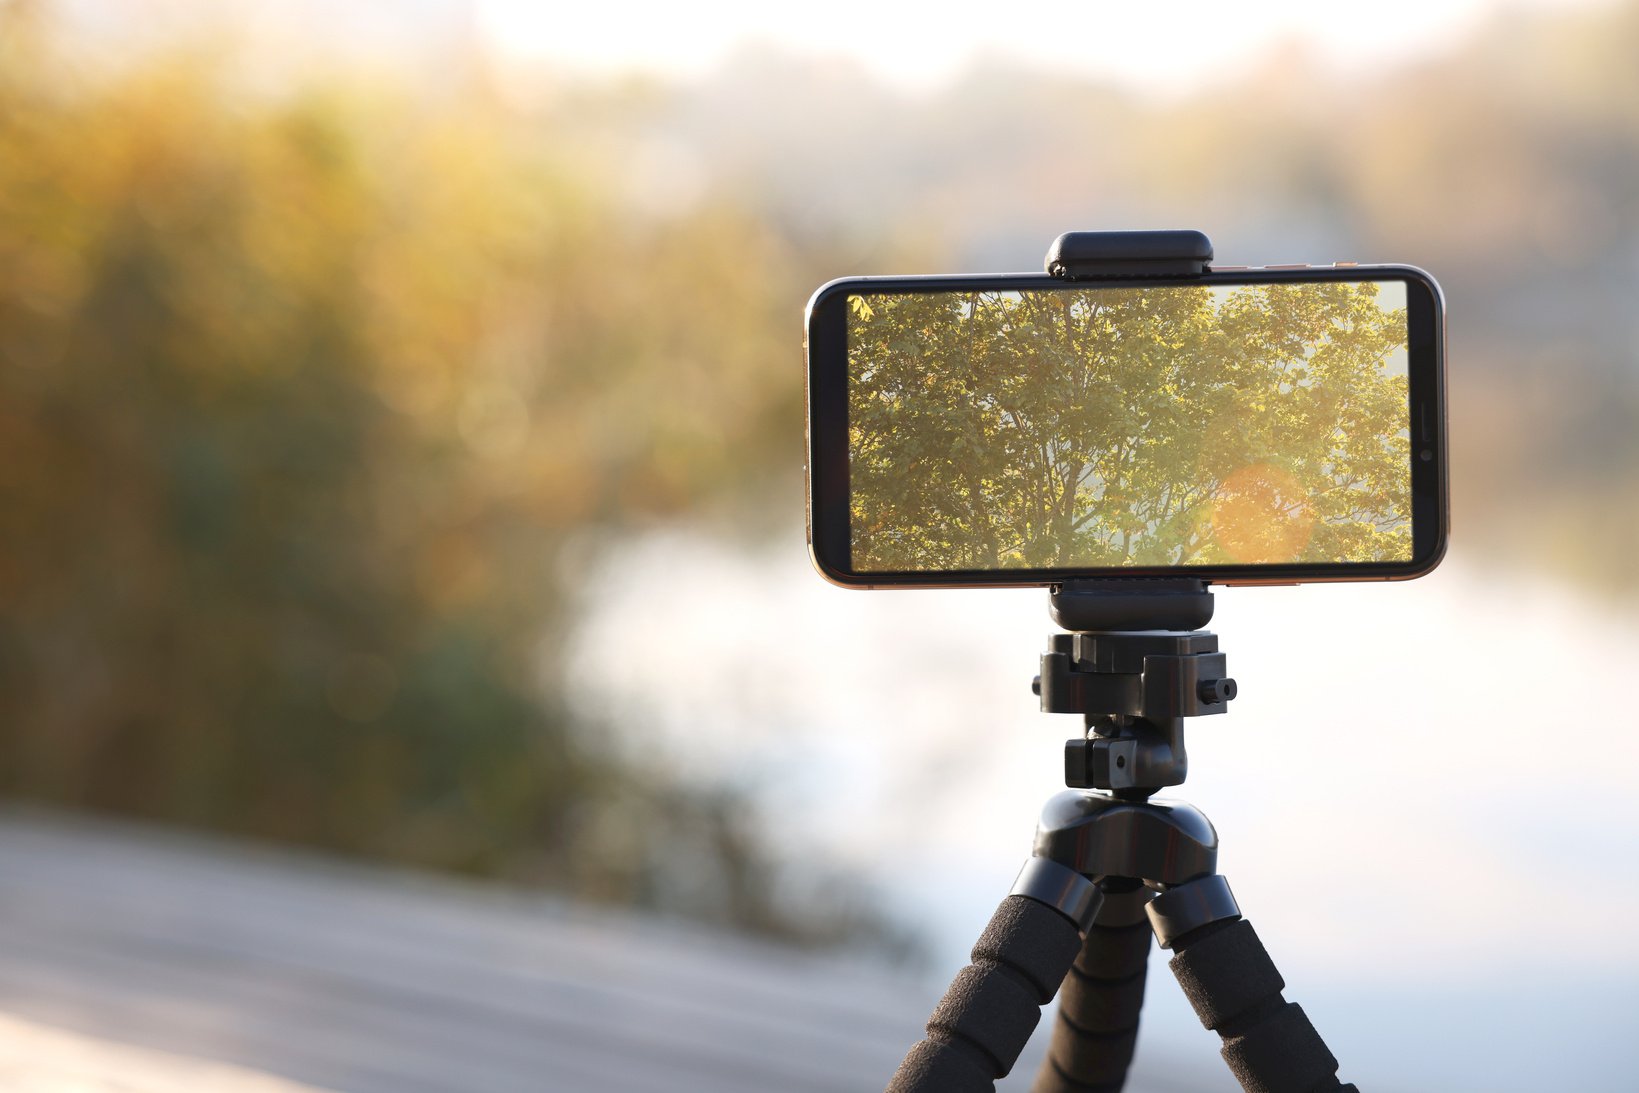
0, 5, 911, 937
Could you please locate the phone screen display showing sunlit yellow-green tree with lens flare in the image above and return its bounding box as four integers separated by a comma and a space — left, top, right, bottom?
847, 282, 1411, 572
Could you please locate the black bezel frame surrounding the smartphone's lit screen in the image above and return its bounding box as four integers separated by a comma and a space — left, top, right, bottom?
803, 265, 1449, 588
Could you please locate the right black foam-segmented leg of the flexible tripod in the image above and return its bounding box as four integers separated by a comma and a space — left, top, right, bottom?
1149, 875, 1355, 1093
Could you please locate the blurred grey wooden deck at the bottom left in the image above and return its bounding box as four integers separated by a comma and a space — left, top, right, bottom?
0, 813, 1206, 1093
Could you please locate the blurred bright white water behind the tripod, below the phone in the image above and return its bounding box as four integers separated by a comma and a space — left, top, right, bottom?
570, 533, 1639, 1091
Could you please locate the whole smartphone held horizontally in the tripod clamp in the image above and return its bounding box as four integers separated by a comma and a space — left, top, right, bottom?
806, 265, 1447, 588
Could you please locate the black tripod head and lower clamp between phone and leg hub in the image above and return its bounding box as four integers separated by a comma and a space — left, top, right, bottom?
1034, 580, 1236, 800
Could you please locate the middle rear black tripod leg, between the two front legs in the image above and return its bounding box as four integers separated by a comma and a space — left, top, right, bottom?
1031, 880, 1152, 1093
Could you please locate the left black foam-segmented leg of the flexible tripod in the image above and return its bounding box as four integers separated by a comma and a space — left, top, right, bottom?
888, 857, 1101, 1093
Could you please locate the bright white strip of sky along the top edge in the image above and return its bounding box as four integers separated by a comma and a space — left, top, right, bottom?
474, 0, 1603, 92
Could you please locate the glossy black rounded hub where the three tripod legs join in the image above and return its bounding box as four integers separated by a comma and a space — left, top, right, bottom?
1036, 791, 1218, 885
